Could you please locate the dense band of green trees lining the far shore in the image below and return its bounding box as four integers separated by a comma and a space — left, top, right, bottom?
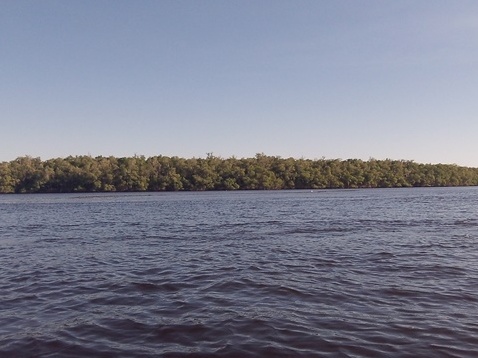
0, 154, 478, 193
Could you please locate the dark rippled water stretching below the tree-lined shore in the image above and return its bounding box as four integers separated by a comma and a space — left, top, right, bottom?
0, 188, 478, 357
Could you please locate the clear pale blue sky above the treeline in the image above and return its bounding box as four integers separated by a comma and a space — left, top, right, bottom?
0, 0, 478, 167
